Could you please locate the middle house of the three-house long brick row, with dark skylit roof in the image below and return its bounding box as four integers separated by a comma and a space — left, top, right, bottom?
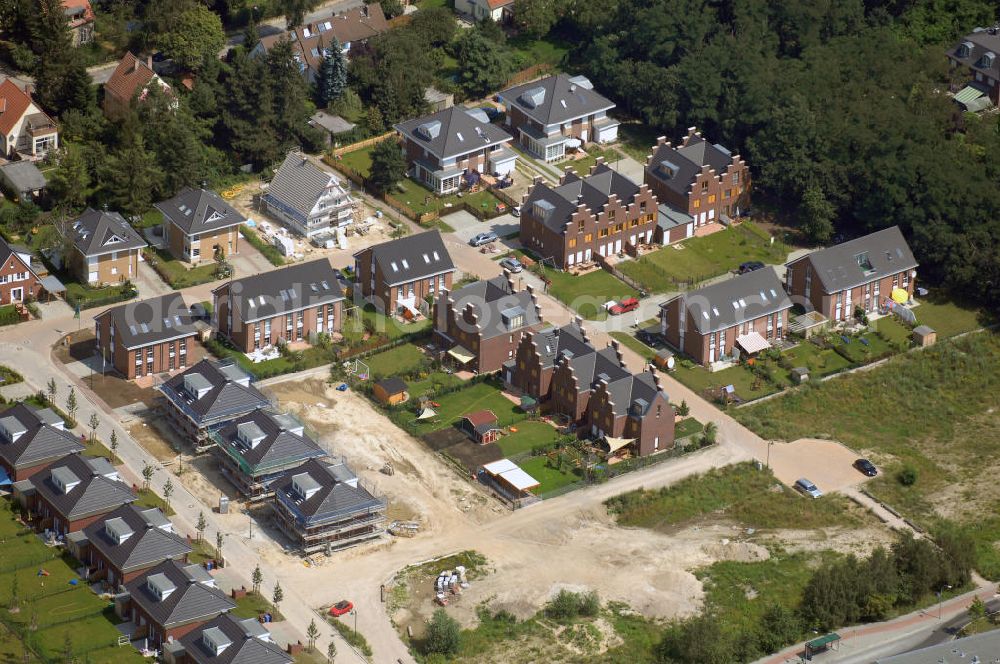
212, 258, 344, 353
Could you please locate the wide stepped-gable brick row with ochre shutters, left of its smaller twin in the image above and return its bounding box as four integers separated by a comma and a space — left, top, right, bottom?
520, 157, 659, 269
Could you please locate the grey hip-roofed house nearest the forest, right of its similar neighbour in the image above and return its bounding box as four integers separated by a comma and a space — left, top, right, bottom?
497, 74, 620, 161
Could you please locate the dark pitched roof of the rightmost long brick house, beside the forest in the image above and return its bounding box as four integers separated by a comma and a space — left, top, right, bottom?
789, 226, 917, 293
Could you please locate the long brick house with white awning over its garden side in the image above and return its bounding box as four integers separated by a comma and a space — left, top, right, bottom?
660, 268, 792, 366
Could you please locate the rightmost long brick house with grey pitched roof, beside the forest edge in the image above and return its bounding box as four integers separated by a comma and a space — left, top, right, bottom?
785, 226, 917, 322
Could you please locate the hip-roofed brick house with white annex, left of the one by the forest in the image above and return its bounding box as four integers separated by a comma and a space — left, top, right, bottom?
395, 106, 517, 195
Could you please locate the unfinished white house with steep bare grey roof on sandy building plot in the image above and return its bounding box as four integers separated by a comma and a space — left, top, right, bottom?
263, 152, 354, 237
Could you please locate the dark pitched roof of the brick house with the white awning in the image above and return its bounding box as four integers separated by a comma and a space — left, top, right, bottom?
660, 267, 792, 334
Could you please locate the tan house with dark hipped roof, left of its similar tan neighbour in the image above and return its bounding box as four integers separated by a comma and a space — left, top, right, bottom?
67, 209, 146, 286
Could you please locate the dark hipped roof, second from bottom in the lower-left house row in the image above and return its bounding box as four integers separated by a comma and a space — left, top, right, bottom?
125, 560, 236, 628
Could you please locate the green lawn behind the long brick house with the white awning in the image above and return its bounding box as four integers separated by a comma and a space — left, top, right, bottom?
618, 221, 789, 293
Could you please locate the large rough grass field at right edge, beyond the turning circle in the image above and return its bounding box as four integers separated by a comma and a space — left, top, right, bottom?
734, 332, 1000, 578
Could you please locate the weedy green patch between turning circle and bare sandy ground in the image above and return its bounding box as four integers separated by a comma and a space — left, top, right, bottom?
605, 463, 858, 531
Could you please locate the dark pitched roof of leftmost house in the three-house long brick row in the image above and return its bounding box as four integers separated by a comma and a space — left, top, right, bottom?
97, 291, 198, 350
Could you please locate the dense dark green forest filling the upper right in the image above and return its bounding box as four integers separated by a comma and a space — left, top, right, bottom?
544, 0, 1000, 307
